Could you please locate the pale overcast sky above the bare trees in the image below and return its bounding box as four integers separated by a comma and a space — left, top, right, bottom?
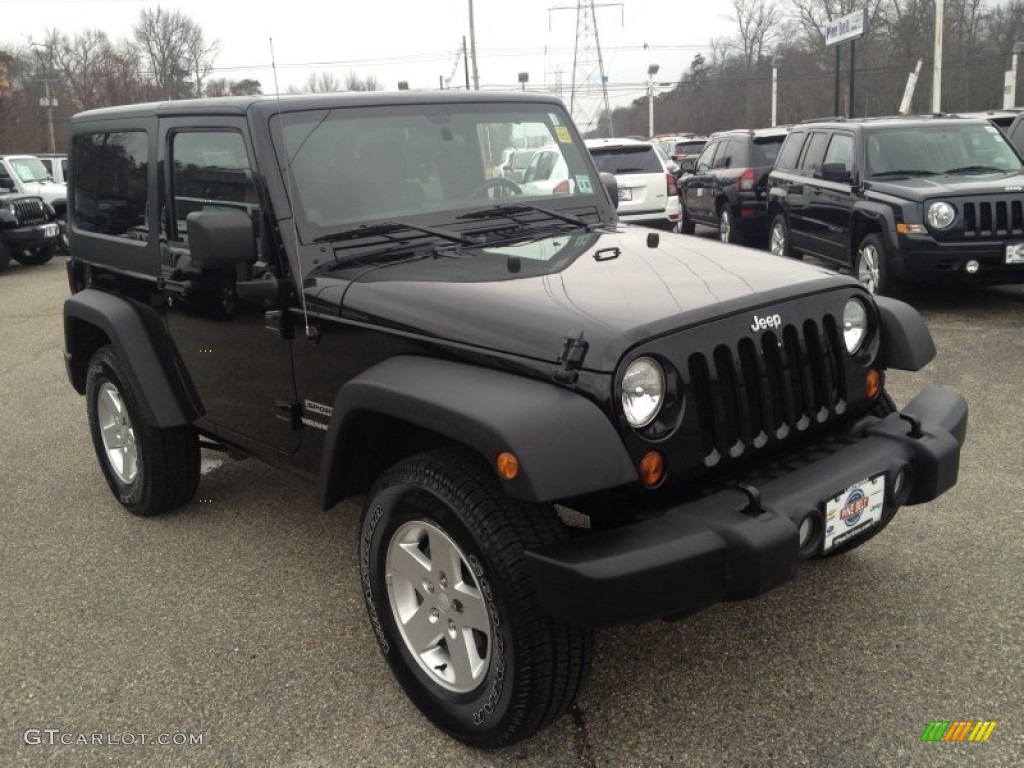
0, 0, 734, 106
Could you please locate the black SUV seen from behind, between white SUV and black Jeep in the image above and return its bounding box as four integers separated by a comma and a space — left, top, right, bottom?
678, 128, 786, 244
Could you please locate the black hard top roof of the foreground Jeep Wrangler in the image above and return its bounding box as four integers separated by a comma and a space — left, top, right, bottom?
72, 90, 562, 123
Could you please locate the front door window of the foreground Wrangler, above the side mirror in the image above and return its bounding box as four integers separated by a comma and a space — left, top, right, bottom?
170, 131, 259, 243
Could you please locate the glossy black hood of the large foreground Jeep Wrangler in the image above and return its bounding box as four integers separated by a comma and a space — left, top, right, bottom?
306, 227, 855, 371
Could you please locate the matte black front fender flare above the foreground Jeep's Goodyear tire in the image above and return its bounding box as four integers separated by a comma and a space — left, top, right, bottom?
317, 355, 637, 509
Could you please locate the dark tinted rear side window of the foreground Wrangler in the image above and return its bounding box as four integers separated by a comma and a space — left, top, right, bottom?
74, 131, 148, 241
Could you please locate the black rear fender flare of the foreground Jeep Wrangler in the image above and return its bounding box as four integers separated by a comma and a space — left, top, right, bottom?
63, 288, 202, 428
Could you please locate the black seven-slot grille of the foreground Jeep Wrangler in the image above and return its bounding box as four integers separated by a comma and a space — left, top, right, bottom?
687, 315, 847, 467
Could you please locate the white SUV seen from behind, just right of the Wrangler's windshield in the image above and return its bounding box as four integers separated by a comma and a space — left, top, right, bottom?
586, 138, 680, 229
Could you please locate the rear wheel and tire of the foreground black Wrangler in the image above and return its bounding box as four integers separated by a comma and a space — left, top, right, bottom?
85, 346, 200, 517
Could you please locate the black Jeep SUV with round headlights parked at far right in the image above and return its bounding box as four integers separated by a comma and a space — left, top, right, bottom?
769, 117, 1024, 295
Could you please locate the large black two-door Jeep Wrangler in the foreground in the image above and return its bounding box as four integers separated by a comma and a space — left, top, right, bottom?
65, 91, 967, 748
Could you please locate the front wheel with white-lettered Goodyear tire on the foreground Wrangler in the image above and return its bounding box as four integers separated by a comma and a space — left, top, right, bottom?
359, 450, 591, 749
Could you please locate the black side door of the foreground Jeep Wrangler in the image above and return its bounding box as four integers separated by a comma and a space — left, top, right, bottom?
160, 118, 300, 452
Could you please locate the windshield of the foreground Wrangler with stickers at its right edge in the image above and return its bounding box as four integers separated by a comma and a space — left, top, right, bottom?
271, 103, 601, 240
